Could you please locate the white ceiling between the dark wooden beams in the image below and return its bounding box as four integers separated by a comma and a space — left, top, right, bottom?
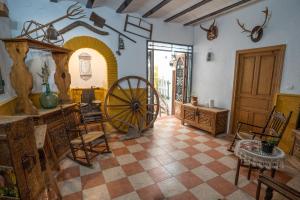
56, 0, 258, 25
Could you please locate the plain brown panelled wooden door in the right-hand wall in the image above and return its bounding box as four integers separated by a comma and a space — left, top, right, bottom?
231, 45, 285, 133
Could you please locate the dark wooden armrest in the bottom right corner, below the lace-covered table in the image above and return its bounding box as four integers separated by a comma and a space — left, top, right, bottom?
258, 174, 300, 200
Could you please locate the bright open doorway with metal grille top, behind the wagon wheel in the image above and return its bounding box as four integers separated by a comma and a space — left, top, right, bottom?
147, 41, 193, 118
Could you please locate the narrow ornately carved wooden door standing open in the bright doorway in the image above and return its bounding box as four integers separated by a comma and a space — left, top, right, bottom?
173, 54, 187, 119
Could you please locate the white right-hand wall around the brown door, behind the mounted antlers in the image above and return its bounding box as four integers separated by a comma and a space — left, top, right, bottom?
192, 0, 300, 109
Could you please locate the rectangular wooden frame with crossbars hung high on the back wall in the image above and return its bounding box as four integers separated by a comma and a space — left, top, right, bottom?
124, 15, 153, 40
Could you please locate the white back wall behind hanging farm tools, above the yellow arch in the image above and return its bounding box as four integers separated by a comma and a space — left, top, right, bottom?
0, 0, 193, 102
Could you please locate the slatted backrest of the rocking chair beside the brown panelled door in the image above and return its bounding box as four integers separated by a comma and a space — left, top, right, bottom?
264, 107, 292, 145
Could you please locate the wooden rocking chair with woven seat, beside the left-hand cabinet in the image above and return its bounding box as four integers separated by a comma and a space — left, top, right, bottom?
61, 106, 110, 167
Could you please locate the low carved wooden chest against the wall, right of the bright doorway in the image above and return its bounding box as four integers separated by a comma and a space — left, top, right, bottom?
181, 104, 228, 136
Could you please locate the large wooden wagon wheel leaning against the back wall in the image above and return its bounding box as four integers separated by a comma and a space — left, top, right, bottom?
104, 76, 159, 133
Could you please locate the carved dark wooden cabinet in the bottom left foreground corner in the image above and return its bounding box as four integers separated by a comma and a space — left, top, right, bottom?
0, 116, 44, 200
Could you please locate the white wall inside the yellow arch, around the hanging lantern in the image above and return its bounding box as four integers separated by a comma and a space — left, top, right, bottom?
69, 48, 107, 88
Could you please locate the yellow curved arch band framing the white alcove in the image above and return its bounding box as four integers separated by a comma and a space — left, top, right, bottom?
64, 36, 118, 89
